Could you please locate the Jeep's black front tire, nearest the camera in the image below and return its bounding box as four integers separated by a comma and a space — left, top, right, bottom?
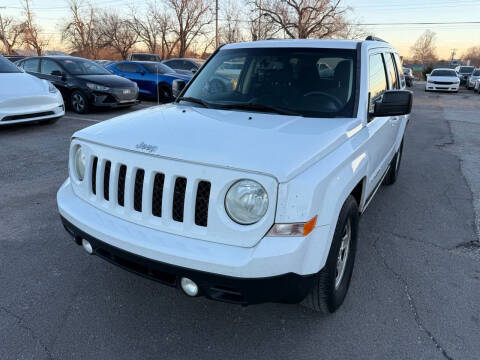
302, 195, 359, 314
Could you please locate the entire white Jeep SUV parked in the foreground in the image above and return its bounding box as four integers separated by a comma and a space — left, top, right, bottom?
57, 38, 412, 312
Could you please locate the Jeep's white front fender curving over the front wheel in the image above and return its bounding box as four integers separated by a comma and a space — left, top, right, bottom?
276, 152, 368, 274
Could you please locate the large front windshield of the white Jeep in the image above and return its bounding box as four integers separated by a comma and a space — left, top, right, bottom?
183, 48, 356, 117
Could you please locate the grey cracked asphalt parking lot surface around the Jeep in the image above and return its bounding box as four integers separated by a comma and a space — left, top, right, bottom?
0, 88, 480, 359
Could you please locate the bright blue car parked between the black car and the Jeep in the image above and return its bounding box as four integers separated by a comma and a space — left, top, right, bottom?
107, 61, 192, 101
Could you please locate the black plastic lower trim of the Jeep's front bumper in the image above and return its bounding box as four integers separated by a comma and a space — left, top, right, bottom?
61, 216, 317, 305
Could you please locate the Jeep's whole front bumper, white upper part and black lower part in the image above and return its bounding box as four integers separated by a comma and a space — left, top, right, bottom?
57, 180, 330, 304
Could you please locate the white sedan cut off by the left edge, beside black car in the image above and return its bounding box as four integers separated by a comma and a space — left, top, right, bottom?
0, 55, 65, 126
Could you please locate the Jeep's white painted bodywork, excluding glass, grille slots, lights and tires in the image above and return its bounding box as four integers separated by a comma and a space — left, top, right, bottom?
57, 40, 408, 278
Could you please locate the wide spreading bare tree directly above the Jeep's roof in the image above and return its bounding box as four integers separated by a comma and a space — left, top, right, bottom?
253, 0, 349, 39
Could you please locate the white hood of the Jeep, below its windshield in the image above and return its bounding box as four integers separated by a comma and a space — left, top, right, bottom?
74, 104, 359, 182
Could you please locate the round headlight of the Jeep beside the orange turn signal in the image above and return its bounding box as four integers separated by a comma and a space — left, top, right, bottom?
225, 180, 268, 225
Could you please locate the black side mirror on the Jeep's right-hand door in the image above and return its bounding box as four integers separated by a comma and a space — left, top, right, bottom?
373, 90, 413, 117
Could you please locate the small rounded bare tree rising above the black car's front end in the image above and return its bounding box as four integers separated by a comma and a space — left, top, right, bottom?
98, 12, 138, 60
